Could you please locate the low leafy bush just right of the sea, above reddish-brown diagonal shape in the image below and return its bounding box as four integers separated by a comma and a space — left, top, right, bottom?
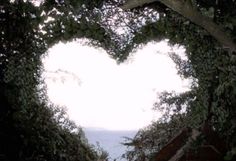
123, 114, 188, 161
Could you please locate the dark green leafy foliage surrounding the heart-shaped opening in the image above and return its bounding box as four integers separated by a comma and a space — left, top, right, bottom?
0, 0, 236, 161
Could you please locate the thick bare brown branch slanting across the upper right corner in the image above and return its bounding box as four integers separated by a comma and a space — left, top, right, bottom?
121, 0, 236, 52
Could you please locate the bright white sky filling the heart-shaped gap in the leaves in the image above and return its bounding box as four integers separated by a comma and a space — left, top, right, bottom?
43, 42, 187, 130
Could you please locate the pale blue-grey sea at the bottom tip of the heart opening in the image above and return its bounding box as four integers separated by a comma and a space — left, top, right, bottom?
84, 128, 137, 161
